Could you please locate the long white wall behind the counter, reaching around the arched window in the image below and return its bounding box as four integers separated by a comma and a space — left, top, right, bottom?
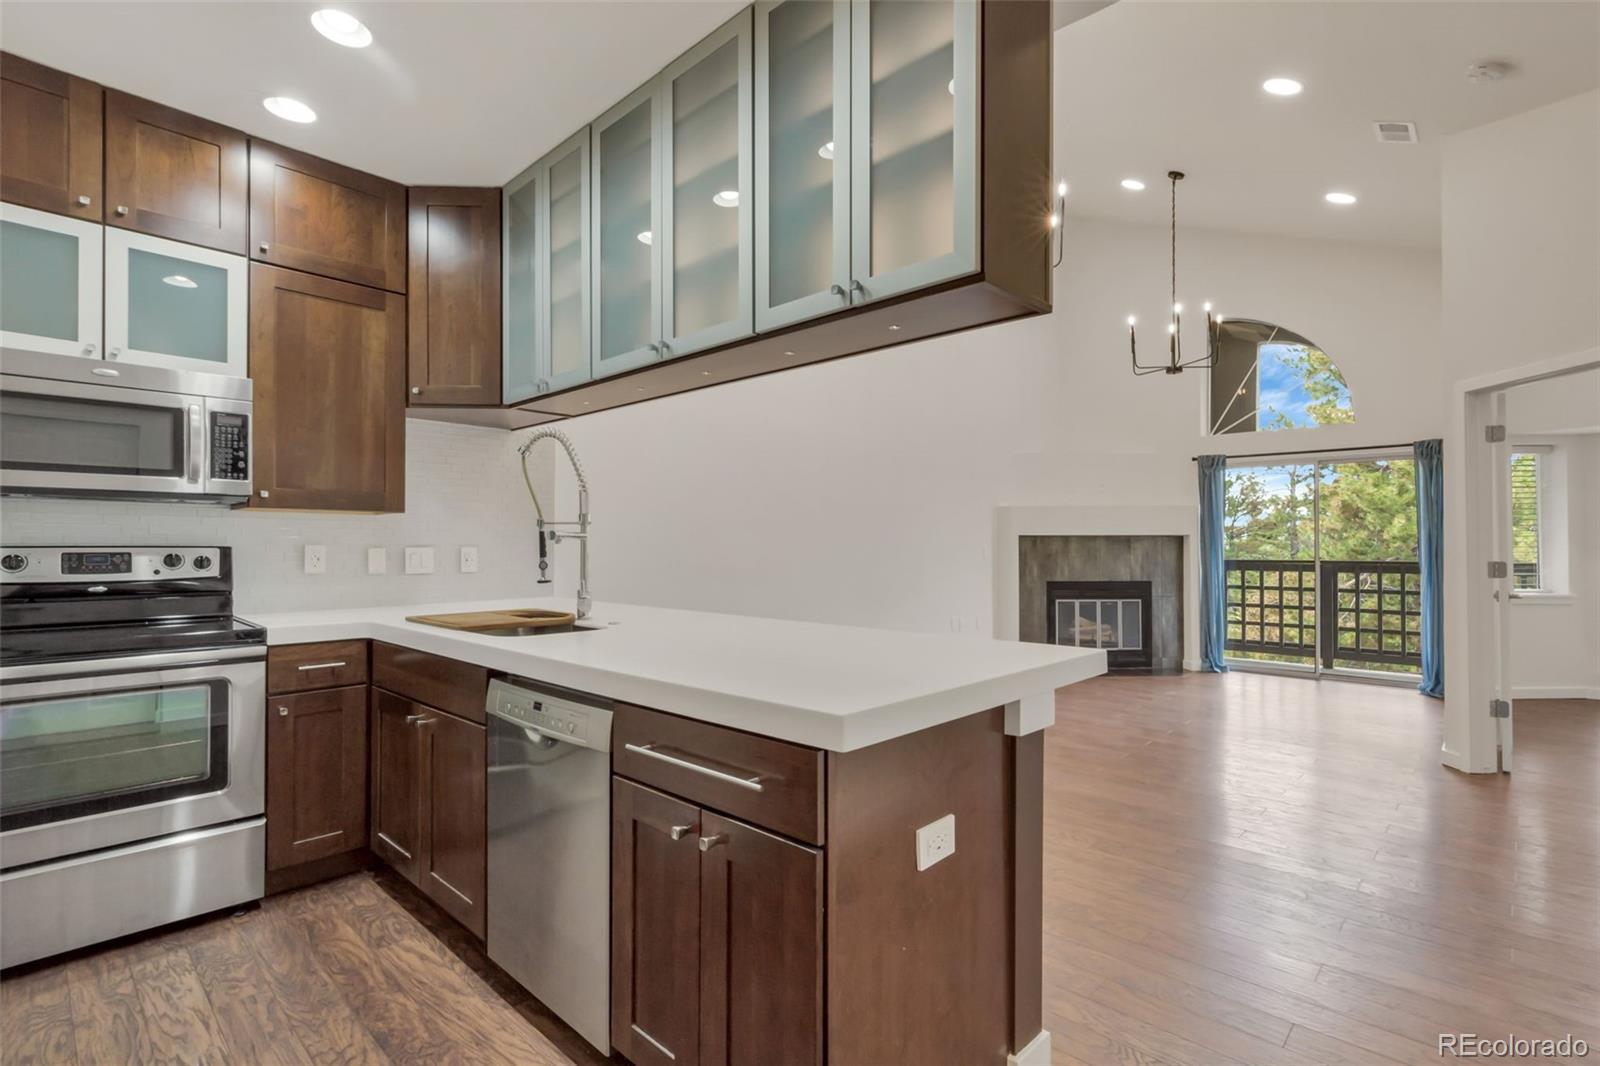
547, 219, 1442, 640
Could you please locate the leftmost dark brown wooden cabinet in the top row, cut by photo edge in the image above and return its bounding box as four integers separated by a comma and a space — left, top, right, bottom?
0, 53, 102, 222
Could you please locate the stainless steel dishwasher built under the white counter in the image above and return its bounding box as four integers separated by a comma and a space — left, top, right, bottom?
486, 677, 611, 1055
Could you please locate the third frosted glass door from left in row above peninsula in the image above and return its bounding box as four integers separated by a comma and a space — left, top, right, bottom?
589, 78, 661, 378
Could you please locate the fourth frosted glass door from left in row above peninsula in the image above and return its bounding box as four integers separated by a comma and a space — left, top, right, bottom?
661, 10, 754, 359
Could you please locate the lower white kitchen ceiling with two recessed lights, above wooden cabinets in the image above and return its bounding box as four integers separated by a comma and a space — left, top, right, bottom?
0, 0, 744, 186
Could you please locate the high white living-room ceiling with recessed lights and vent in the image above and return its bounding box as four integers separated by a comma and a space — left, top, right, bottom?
1056, 0, 1600, 246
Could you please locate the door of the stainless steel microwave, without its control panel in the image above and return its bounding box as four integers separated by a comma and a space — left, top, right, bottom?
0, 375, 206, 496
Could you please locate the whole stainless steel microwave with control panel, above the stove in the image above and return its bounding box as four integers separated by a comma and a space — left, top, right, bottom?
0, 351, 254, 504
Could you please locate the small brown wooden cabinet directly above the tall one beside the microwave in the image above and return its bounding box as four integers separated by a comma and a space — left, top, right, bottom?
250, 141, 406, 293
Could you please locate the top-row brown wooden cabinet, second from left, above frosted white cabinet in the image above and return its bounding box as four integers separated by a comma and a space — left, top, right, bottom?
104, 90, 250, 254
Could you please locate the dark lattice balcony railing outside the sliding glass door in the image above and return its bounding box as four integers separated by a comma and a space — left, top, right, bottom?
1226, 559, 1422, 671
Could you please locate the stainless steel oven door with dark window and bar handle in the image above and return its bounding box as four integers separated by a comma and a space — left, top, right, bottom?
0, 648, 266, 869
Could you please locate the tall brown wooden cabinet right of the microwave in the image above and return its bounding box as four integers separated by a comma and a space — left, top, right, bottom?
250, 262, 405, 512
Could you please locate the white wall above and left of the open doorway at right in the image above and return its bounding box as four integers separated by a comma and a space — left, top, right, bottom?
1440, 91, 1600, 771
